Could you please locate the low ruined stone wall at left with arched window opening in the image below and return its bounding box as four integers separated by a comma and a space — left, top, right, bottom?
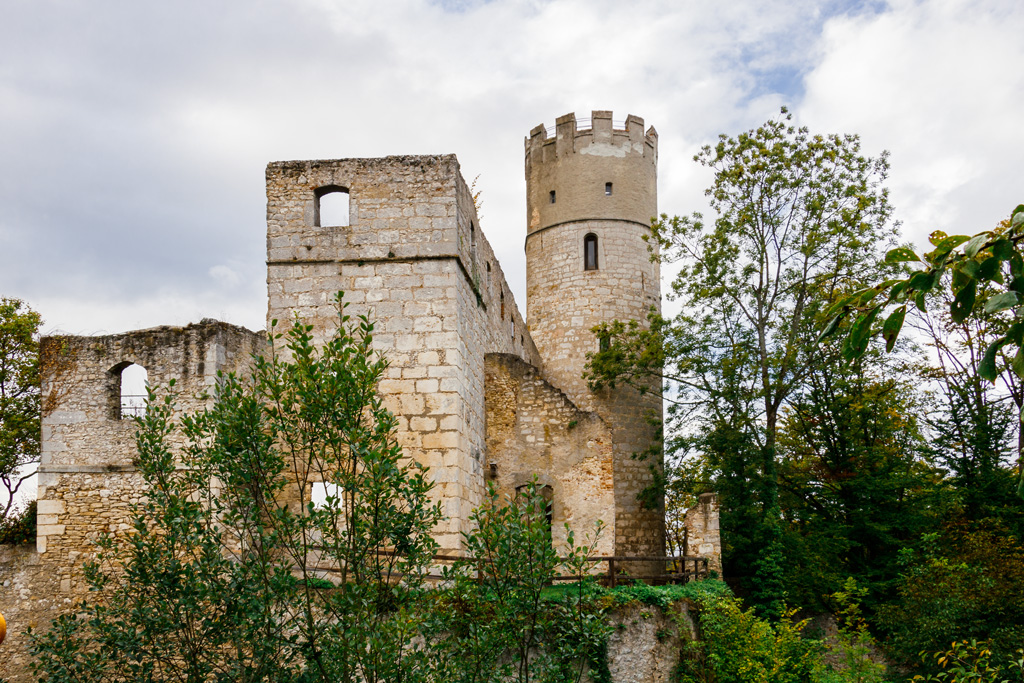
37, 321, 265, 594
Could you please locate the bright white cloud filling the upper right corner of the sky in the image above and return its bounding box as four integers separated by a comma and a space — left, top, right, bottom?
799, 0, 1024, 244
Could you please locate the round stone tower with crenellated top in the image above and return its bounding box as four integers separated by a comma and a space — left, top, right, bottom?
525, 112, 665, 555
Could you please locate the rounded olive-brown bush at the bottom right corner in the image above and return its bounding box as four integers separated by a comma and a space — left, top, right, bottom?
878, 526, 1024, 674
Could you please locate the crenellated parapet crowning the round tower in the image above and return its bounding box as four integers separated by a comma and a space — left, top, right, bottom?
524, 110, 657, 167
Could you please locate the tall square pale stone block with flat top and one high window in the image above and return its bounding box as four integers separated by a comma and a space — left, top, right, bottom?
266, 155, 540, 549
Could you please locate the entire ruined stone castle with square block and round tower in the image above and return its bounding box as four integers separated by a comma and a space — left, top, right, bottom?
0, 112, 721, 679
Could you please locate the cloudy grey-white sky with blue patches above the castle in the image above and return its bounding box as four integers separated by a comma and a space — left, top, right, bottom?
0, 0, 1024, 334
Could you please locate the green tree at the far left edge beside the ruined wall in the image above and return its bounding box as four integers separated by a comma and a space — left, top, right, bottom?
0, 298, 42, 524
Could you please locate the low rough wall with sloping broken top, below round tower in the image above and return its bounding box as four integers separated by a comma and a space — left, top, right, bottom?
486, 353, 615, 569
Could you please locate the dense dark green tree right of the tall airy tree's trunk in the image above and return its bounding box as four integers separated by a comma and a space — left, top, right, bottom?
779, 353, 939, 608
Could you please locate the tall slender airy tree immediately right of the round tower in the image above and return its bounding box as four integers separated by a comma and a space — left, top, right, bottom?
588, 110, 895, 614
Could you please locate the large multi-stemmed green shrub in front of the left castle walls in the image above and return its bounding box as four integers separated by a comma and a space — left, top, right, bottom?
33, 295, 439, 683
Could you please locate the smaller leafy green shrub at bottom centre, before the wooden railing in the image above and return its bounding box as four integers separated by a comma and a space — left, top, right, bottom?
428, 482, 610, 683
